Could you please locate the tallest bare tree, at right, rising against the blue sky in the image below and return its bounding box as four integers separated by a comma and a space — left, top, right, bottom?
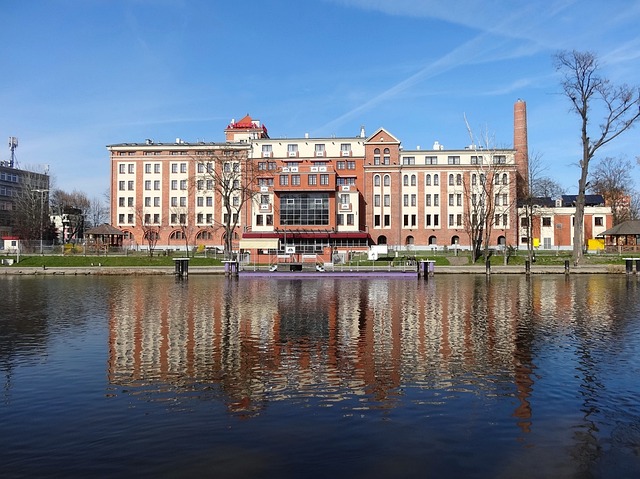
555, 50, 640, 264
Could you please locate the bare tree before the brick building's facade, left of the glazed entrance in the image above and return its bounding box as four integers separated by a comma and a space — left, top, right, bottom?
195, 145, 266, 258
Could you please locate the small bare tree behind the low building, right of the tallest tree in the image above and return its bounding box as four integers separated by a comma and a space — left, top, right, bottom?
588, 157, 634, 225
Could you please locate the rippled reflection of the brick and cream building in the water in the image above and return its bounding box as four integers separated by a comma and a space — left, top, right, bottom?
108, 275, 624, 433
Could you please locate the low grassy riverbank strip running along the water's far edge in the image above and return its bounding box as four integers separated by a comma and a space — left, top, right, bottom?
0, 264, 638, 277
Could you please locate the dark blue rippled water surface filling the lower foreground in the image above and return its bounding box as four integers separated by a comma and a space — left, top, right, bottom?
0, 275, 640, 479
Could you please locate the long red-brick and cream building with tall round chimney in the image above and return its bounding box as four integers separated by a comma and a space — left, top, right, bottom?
107, 100, 528, 261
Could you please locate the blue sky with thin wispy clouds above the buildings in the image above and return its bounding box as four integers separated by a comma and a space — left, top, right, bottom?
0, 0, 640, 197
